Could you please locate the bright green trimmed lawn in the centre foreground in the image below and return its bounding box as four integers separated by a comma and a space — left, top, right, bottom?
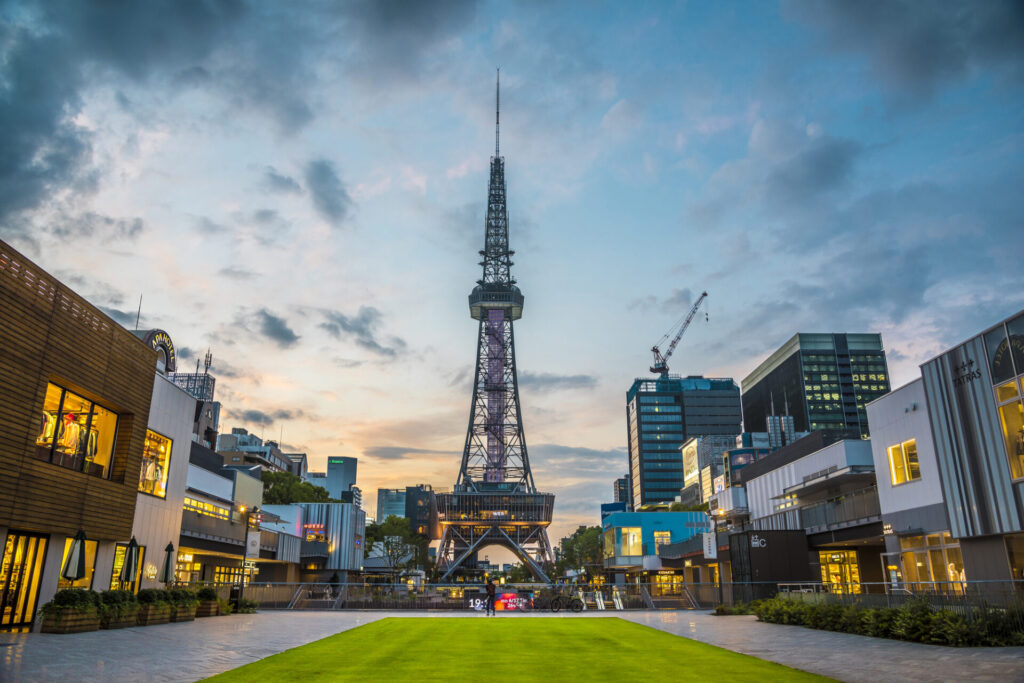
207, 616, 828, 683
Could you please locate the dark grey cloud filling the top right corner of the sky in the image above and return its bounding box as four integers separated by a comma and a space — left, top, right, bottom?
783, 0, 1024, 99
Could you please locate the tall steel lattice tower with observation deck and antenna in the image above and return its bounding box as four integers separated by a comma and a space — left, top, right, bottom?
437, 72, 555, 582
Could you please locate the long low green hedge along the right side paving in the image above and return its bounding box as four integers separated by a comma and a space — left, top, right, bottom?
753, 597, 1024, 647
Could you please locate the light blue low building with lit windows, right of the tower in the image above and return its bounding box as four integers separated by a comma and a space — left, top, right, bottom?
601, 512, 711, 583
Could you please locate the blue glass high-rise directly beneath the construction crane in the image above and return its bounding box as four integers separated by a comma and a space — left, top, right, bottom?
626, 375, 741, 509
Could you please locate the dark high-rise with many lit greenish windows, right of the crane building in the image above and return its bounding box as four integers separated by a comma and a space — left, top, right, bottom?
742, 333, 890, 437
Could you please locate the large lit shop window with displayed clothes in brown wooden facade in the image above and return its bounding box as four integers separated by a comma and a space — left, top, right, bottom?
36, 384, 118, 479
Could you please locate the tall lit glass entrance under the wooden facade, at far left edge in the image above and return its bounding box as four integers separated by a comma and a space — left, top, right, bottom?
0, 531, 47, 630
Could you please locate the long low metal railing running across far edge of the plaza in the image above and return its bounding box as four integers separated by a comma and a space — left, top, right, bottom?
178, 581, 1024, 628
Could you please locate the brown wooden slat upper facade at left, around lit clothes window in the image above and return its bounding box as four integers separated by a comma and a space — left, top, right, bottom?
0, 241, 157, 541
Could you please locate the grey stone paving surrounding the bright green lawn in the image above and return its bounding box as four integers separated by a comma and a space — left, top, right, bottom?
6, 610, 1024, 683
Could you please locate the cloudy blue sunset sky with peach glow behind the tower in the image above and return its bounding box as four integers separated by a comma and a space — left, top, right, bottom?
0, 0, 1024, 557
